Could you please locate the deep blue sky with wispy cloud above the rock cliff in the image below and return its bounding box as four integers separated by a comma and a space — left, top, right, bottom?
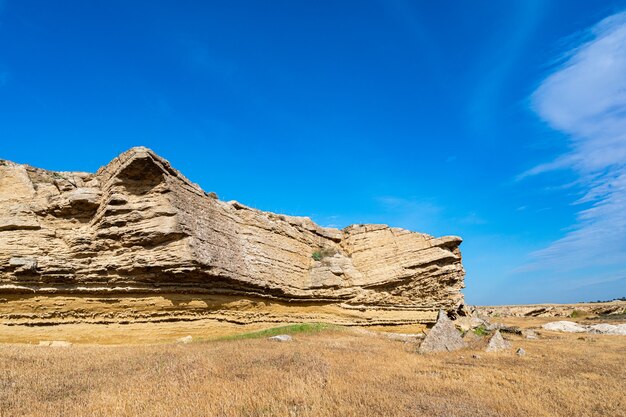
0, 0, 626, 304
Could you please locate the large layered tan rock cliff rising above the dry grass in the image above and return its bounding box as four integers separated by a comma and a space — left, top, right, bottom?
0, 148, 464, 324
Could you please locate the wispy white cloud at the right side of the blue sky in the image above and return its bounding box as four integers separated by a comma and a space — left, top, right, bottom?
521, 12, 626, 270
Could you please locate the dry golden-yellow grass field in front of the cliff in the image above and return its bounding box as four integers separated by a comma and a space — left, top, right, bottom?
0, 322, 626, 417
